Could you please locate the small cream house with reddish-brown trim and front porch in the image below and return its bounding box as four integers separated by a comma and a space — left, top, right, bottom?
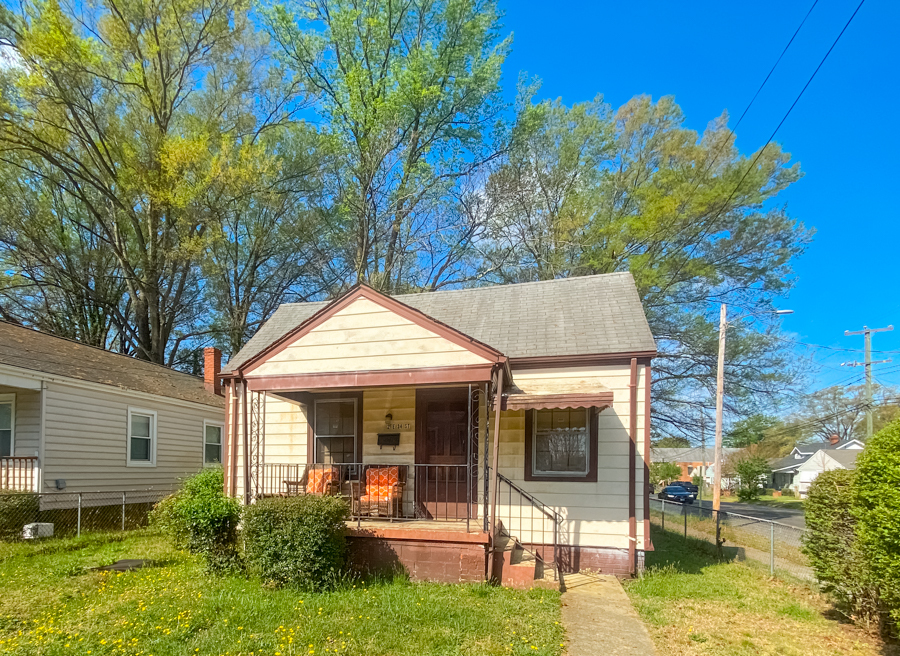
222, 273, 656, 586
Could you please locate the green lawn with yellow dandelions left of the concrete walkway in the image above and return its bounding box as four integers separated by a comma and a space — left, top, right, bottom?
0, 532, 563, 656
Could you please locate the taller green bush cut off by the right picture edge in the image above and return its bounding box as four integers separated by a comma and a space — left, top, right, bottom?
855, 421, 900, 625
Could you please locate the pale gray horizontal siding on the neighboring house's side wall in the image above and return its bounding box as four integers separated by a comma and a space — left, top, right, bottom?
44, 383, 225, 491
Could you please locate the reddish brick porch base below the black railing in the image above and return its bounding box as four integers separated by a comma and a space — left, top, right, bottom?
348, 527, 488, 583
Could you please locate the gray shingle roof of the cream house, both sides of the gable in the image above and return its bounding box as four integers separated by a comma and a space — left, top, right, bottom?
224, 273, 656, 372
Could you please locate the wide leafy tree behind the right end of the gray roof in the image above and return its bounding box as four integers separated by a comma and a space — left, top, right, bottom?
483, 88, 811, 436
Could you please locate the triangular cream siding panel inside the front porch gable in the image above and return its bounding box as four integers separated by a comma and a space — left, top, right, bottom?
249, 299, 487, 377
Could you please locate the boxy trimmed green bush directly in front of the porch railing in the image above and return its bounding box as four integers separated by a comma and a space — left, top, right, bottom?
243, 495, 349, 590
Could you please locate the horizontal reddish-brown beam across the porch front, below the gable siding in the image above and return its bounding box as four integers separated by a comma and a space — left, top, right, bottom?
247, 362, 494, 391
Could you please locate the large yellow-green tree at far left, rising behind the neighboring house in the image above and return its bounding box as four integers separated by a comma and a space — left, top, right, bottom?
0, 0, 302, 364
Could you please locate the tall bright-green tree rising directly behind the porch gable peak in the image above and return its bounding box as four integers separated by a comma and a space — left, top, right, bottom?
266, 0, 510, 292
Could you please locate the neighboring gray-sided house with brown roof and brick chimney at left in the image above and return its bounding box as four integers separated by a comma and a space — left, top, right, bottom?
0, 321, 225, 492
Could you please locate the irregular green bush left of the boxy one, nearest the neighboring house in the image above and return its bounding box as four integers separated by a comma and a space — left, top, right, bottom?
150, 469, 241, 573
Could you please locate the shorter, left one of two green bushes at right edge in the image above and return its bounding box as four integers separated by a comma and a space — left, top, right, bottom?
803, 469, 880, 627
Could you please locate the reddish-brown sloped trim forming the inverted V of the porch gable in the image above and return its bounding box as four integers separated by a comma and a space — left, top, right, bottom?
230, 284, 503, 375
